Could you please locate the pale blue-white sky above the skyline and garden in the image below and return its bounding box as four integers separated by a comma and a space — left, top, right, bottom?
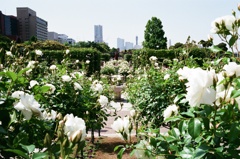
0, 0, 240, 47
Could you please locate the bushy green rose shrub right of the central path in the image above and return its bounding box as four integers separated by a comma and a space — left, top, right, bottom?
126, 62, 185, 128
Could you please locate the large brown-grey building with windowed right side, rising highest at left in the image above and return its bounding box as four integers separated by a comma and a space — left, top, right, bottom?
17, 7, 48, 41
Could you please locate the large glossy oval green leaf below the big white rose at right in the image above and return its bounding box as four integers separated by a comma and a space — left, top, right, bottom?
188, 118, 202, 139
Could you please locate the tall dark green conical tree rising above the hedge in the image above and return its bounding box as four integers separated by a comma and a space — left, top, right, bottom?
143, 17, 167, 50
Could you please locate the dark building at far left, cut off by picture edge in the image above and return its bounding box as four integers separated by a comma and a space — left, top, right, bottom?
0, 11, 19, 40
